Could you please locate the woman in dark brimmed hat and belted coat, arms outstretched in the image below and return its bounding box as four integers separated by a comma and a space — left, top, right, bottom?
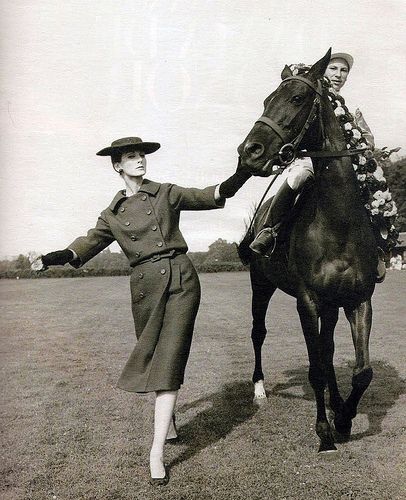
32, 137, 250, 485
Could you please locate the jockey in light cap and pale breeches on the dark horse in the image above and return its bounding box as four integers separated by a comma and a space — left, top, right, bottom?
250, 53, 396, 282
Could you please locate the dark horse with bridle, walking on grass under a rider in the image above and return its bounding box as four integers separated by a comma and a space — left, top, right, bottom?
238, 50, 378, 452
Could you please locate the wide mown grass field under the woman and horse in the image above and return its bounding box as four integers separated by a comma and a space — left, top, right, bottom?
0, 271, 406, 500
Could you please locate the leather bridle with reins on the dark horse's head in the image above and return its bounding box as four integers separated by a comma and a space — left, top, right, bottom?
256, 75, 365, 166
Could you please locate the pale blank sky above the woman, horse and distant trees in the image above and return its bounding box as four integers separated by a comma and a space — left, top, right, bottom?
0, 0, 406, 258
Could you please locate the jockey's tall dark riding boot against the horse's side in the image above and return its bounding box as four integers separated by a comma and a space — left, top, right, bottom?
250, 180, 297, 256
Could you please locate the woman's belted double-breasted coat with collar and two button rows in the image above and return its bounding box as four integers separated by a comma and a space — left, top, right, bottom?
69, 179, 224, 392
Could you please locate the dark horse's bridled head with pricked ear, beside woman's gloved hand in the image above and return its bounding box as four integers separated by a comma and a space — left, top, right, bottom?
238, 49, 331, 176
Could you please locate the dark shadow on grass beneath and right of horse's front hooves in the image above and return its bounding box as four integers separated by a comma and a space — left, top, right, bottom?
271, 361, 406, 441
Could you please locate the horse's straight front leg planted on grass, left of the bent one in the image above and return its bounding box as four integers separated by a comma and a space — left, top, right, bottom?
297, 293, 337, 453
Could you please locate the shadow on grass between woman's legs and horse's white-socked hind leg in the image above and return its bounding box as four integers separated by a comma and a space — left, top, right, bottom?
171, 381, 258, 467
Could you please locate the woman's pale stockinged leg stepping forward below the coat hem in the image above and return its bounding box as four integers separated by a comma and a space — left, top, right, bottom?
149, 391, 178, 478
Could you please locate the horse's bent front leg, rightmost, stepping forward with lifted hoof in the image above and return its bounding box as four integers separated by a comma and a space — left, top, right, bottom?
334, 299, 373, 439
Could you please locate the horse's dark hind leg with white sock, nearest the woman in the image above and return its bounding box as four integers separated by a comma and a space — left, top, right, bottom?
250, 265, 276, 401
